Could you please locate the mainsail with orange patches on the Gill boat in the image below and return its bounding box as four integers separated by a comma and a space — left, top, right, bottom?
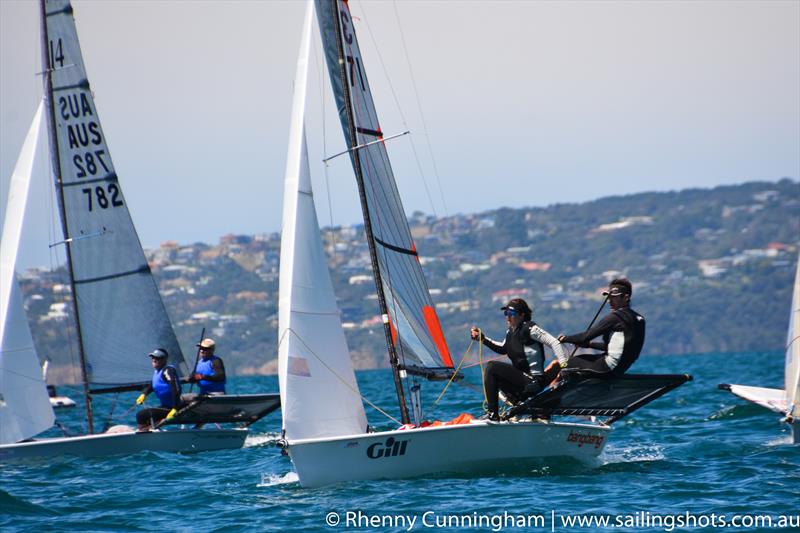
316, 0, 453, 374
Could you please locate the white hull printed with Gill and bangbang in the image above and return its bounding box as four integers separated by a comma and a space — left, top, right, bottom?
288, 421, 610, 487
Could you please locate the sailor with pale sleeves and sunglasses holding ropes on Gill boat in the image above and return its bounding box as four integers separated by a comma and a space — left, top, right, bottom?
470, 298, 567, 420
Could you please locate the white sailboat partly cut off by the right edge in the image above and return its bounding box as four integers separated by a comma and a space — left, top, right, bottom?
719, 252, 800, 444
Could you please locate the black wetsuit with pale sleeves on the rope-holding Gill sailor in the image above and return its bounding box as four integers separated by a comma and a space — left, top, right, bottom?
483, 322, 567, 413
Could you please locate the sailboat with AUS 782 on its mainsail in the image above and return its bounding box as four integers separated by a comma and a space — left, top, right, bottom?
0, 0, 279, 460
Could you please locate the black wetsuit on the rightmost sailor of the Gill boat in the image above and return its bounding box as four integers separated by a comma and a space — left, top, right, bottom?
563, 307, 645, 376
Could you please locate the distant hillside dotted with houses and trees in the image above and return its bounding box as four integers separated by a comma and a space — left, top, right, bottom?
23, 179, 800, 373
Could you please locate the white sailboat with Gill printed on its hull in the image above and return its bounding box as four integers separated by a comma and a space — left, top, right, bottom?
278, 0, 691, 487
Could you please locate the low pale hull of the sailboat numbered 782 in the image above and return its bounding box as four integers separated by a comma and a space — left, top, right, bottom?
0, 429, 248, 462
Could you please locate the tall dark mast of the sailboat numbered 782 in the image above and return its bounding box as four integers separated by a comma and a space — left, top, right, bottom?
39, 0, 94, 433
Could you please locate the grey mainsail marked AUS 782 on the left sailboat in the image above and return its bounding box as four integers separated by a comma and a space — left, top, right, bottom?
43, 0, 186, 385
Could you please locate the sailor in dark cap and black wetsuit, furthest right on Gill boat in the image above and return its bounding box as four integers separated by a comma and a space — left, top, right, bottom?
545, 278, 645, 383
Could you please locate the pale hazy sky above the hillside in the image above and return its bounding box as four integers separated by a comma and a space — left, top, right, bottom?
0, 0, 800, 269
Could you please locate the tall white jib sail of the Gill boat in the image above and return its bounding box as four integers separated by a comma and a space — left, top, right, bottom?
278, 3, 367, 442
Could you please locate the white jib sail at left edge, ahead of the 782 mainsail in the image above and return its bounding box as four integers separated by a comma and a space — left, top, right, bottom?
0, 104, 55, 444
